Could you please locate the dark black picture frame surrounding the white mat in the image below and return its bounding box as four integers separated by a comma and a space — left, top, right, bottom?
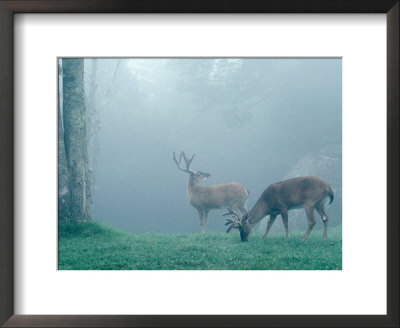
0, 0, 400, 327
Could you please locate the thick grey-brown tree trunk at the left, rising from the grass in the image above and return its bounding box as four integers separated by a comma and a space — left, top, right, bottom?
62, 58, 91, 222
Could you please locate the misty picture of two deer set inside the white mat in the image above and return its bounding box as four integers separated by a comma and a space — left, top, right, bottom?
58, 58, 342, 270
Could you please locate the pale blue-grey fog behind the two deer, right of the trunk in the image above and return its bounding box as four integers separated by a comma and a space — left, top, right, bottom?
85, 58, 342, 233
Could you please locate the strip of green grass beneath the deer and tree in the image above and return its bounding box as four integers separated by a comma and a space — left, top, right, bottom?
58, 222, 342, 270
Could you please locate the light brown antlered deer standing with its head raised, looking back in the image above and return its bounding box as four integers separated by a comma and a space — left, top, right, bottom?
172, 151, 249, 233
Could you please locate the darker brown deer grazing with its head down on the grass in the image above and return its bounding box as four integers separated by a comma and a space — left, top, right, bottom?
223, 176, 334, 242
